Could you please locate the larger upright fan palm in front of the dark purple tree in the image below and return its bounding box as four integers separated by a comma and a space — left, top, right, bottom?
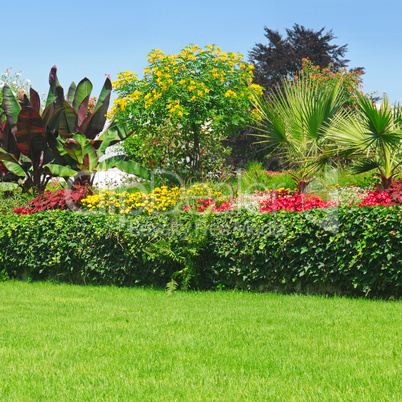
253, 79, 344, 193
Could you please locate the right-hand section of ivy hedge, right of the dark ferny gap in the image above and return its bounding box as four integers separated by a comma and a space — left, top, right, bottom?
211, 207, 402, 295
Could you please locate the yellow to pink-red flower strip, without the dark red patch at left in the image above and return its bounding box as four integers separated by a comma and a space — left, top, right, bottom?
77, 183, 402, 214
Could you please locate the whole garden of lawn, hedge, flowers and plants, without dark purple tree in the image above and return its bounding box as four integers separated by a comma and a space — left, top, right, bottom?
0, 45, 402, 400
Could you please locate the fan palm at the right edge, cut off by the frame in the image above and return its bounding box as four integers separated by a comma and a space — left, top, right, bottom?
328, 93, 402, 190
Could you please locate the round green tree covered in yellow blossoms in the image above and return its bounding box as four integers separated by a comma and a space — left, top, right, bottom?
110, 45, 262, 175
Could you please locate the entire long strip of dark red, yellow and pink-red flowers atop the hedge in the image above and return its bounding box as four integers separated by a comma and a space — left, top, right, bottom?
14, 183, 402, 215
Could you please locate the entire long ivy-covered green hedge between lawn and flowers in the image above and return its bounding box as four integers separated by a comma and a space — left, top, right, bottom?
0, 206, 402, 297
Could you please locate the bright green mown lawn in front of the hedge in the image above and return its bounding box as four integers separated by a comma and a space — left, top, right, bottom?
0, 281, 402, 401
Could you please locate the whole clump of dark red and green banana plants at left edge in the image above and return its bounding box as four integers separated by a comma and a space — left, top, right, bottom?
0, 66, 149, 192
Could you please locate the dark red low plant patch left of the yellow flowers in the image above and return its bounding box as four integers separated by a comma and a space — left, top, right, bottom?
14, 186, 91, 215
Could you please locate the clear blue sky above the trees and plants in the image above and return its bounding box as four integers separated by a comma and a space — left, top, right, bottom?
0, 0, 402, 102
